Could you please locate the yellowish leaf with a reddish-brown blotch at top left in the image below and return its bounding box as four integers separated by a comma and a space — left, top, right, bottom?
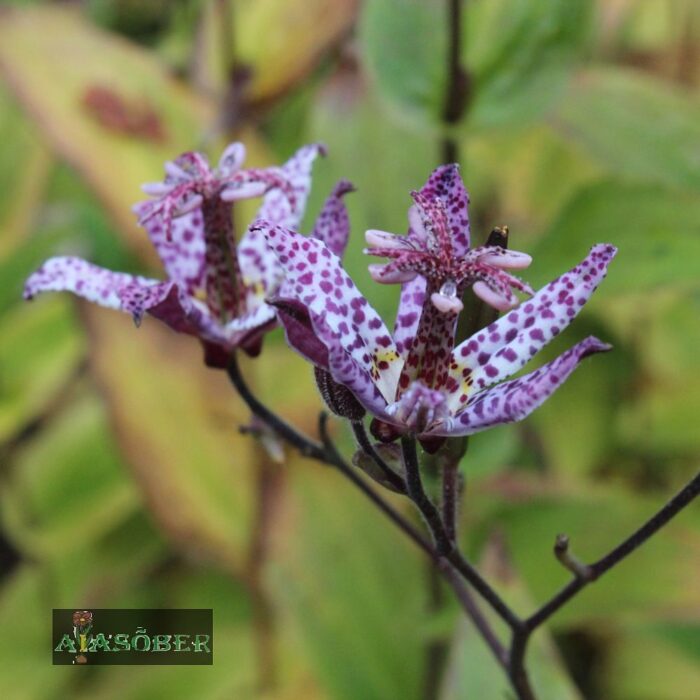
0, 5, 212, 257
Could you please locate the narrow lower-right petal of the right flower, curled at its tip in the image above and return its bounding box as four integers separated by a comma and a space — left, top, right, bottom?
428, 336, 611, 436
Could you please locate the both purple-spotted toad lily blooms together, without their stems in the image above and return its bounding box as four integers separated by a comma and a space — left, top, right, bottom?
25, 143, 616, 440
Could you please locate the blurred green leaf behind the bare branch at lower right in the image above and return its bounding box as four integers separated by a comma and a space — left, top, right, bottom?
471, 477, 700, 629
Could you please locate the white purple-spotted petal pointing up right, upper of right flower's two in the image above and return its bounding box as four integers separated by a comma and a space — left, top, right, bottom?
447, 244, 617, 411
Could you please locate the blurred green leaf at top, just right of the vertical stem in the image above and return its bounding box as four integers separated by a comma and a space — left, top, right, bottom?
464, 0, 591, 128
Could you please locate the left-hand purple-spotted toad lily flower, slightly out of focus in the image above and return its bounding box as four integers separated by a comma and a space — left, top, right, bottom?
24, 143, 352, 366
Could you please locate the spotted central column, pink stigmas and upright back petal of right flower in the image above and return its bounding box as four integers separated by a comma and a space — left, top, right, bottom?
365, 165, 534, 396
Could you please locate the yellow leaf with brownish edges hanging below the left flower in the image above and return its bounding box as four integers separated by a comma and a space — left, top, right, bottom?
84, 306, 256, 573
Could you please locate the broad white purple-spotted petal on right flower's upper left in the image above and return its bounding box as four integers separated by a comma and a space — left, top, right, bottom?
264, 226, 402, 402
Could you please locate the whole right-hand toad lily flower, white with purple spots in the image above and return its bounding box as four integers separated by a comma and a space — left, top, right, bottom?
261, 166, 616, 438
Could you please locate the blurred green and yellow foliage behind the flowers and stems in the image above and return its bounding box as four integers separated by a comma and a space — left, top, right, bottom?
0, 0, 700, 700
